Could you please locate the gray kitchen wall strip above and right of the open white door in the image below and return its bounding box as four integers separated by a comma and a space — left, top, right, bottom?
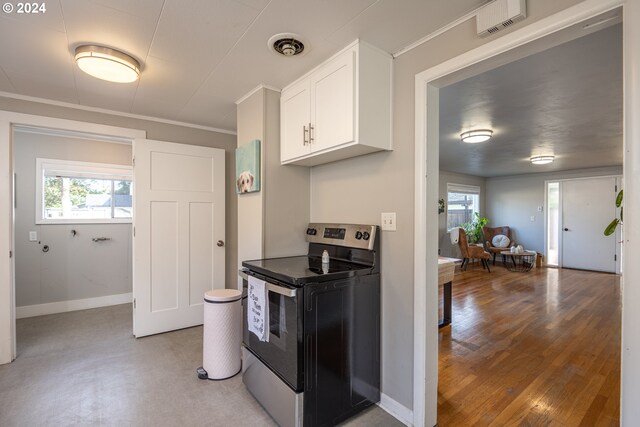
0, 96, 238, 288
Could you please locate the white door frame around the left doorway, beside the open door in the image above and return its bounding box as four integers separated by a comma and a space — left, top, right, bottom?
0, 110, 147, 364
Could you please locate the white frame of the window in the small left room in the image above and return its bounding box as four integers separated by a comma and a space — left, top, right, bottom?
35, 158, 133, 224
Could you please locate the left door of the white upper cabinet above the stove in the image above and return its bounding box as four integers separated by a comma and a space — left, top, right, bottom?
280, 80, 311, 162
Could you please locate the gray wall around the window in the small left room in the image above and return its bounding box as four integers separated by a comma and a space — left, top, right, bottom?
13, 132, 131, 307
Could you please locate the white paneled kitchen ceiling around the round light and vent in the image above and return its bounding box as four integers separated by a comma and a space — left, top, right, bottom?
0, 0, 487, 131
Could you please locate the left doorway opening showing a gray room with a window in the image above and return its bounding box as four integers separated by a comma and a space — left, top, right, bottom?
11, 125, 133, 354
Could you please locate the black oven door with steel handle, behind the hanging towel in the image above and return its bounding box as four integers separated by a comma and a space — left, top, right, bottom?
240, 271, 304, 392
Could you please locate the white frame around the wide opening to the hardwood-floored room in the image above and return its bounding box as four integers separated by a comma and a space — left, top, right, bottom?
413, 0, 640, 426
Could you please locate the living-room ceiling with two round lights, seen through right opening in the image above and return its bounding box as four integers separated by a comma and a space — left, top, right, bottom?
440, 24, 623, 177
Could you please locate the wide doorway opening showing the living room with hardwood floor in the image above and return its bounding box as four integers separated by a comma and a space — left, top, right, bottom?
438, 18, 623, 425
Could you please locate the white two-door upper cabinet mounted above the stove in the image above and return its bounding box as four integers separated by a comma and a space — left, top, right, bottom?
280, 41, 392, 166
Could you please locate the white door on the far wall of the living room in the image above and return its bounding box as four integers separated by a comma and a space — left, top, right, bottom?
561, 177, 617, 273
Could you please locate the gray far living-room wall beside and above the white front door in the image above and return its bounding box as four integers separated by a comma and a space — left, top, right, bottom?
485, 166, 622, 253
